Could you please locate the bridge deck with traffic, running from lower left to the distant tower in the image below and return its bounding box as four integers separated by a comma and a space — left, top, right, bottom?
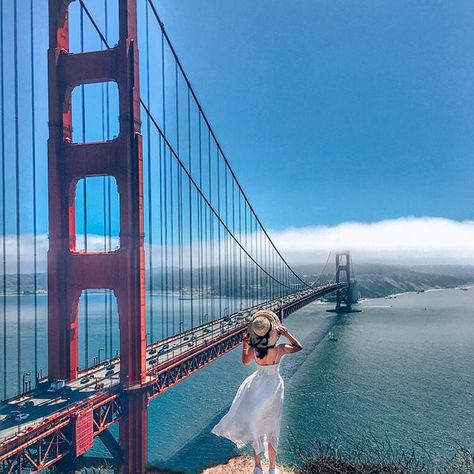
0, 283, 346, 472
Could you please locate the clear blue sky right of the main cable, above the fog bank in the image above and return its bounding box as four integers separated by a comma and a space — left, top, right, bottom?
153, 0, 474, 229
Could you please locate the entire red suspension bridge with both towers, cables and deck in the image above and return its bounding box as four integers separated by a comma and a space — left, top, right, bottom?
0, 0, 354, 473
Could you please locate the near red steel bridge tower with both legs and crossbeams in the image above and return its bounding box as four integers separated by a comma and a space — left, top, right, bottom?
48, 0, 148, 473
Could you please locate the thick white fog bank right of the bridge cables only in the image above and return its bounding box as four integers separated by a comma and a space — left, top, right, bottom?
270, 217, 474, 265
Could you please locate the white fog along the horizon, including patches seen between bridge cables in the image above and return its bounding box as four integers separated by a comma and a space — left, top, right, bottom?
0, 217, 474, 273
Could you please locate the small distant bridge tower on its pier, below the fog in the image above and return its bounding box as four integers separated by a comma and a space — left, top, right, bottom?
327, 251, 361, 313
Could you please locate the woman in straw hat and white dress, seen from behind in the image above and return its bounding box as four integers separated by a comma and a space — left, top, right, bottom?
211, 310, 303, 474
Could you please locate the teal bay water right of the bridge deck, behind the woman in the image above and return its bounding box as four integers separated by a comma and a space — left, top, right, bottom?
149, 288, 474, 473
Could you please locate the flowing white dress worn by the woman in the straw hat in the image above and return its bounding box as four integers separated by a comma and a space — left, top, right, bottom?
211, 348, 284, 459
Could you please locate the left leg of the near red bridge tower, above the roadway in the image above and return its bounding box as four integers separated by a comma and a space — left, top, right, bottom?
48, 0, 78, 379
